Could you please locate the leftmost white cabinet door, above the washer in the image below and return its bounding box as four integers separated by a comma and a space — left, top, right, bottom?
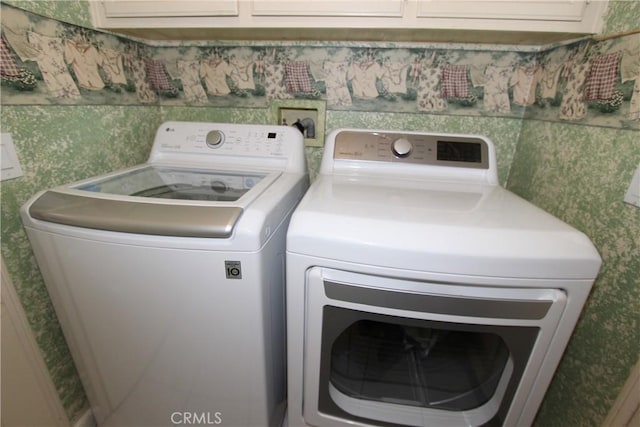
100, 0, 238, 19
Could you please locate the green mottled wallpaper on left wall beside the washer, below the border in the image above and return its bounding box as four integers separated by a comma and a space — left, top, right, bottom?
0, 106, 160, 418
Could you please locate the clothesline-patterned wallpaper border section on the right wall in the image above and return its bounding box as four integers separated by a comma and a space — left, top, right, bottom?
524, 33, 640, 129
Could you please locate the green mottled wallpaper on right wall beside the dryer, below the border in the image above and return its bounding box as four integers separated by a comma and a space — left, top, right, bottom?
508, 121, 640, 427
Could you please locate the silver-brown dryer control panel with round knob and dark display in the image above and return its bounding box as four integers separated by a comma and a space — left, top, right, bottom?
333, 130, 489, 169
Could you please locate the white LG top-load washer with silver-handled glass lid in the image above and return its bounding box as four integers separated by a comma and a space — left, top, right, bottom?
22, 122, 308, 427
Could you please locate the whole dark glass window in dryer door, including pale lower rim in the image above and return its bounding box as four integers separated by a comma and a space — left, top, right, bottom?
318, 305, 539, 425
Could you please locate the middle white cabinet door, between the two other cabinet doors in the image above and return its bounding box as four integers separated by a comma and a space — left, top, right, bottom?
251, 0, 404, 17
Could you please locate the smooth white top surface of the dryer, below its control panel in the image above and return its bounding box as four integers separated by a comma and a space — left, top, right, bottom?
287, 175, 600, 279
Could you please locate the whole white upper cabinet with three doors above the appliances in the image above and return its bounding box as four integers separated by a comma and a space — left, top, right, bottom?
90, 0, 607, 34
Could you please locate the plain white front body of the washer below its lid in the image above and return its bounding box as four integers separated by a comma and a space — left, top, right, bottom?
27, 205, 285, 427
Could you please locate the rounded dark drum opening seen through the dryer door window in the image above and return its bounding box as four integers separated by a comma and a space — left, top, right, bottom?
330, 320, 509, 411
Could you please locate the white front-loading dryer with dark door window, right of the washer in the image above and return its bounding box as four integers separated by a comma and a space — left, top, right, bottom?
287, 130, 601, 427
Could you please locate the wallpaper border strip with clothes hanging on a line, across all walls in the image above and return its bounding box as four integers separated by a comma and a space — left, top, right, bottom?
0, 4, 640, 129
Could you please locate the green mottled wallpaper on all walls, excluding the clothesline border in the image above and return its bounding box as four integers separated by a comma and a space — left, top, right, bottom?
0, 0, 640, 427
